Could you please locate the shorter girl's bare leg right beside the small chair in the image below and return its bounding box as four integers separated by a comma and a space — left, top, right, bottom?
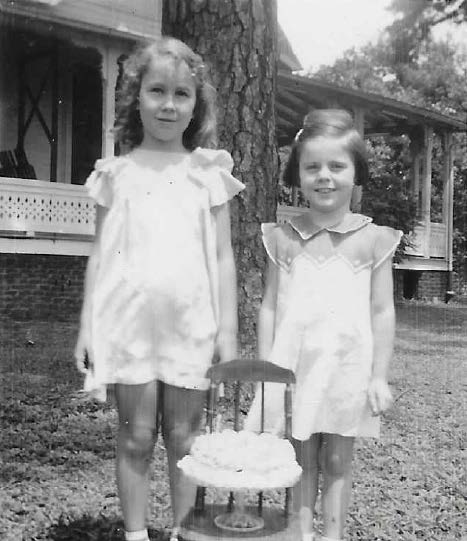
293, 434, 321, 535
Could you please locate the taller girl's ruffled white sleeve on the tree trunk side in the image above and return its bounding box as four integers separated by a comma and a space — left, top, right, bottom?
193, 148, 245, 207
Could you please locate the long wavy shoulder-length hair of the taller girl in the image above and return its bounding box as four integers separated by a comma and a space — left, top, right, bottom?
114, 37, 216, 150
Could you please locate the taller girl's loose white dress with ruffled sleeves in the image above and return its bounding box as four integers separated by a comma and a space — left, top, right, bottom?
85, 148, 244, 398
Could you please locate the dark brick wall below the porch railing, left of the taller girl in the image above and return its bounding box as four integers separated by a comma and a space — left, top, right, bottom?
0, 254, 87, 321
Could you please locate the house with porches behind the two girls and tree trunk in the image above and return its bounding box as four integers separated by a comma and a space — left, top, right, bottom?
0, 0, 465, 320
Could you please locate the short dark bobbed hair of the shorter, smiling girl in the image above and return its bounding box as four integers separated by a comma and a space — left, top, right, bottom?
283, 109, 369, 187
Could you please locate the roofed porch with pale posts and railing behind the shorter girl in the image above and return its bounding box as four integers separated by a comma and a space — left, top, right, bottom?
276, 71, 467, 272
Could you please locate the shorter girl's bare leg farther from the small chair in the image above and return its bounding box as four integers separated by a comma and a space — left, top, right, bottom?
322, 434, 355, 539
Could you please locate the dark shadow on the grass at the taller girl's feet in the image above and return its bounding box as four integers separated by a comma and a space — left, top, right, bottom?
42, 515, 166, 541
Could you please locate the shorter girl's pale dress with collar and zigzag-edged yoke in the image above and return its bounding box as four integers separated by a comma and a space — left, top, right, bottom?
245, 213, 402, 441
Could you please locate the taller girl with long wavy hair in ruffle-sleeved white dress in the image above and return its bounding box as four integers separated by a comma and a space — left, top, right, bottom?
75, 38, 244, 541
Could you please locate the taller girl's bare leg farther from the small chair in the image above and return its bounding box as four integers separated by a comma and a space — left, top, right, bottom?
115, 381, 158, 532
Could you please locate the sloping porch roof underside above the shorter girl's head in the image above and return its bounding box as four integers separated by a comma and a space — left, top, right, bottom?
276, 71, 467, 146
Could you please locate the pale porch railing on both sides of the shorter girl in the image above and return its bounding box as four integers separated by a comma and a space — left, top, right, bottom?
277, 205, 447, 259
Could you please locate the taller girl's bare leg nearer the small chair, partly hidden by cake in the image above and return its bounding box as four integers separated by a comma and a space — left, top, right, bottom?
162, 384, 207, 530
